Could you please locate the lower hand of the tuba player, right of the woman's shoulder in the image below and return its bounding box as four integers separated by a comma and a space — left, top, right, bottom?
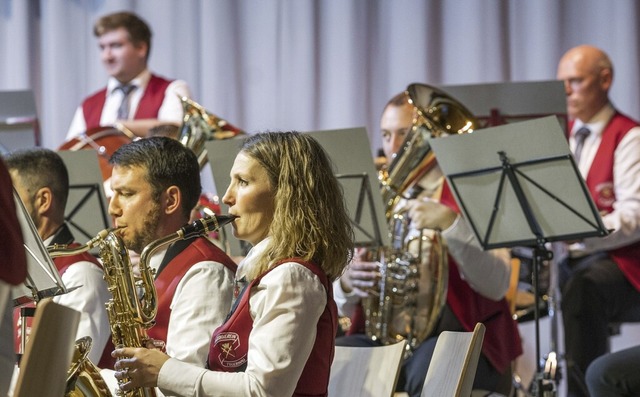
340, 248, 380, 298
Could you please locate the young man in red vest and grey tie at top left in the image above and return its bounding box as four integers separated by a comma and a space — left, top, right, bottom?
67, 12, 190, 139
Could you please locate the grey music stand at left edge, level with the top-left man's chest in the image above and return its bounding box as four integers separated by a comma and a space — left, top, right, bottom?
0, 90, 40, 154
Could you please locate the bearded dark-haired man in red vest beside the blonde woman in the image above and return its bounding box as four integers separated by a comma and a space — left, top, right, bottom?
109, 136, 236, 367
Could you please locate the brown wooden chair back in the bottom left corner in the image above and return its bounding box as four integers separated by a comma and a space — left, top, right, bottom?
13, 298, 80, 397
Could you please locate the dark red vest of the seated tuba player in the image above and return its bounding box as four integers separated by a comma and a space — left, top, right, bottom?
348, 183, 522, 373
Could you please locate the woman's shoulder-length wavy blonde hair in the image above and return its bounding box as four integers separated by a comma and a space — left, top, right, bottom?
241, 131, 354, 280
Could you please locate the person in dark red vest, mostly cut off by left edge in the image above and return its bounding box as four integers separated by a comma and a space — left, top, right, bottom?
0, 160, 27, 396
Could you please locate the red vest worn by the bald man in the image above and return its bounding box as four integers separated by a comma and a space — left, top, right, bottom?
572, 112, 640, 291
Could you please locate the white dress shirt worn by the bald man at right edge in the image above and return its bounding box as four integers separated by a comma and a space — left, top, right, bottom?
569, 104, 640, 256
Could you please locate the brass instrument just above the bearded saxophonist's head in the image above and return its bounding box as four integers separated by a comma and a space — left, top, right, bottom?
178, 97, 244, 168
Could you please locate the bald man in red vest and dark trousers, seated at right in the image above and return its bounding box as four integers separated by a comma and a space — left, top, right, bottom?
557, 45, 640, 396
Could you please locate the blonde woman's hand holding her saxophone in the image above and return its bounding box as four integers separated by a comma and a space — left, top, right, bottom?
111, 341, 170, 391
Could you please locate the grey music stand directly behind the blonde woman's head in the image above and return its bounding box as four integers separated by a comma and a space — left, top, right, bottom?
205, 127, 389, 255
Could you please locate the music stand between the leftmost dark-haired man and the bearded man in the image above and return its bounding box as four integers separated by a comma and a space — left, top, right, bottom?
58, 150, 111, 246
